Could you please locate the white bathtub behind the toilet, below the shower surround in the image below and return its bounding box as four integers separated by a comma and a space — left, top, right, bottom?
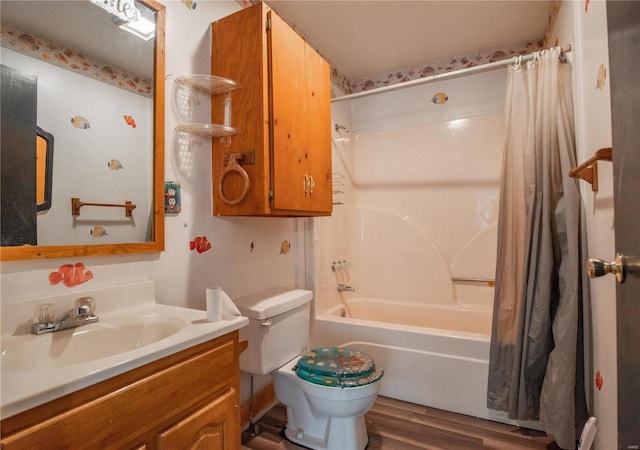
312, 298, 539, 428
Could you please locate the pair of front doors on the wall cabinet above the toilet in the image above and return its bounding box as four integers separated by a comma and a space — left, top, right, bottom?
268, 13, 331, 213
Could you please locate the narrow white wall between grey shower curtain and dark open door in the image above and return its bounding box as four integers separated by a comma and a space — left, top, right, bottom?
554, 0, 618, 450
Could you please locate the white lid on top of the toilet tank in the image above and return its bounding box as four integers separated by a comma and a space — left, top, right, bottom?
233, 288, 313, 319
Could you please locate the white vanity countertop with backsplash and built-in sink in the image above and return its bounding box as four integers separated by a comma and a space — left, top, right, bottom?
0, 282, 249, 419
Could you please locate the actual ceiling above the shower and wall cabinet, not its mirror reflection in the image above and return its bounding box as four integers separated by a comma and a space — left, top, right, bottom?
266, 0, 550, 81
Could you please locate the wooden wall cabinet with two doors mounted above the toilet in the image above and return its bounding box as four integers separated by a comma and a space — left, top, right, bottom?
211, 2, 332, 216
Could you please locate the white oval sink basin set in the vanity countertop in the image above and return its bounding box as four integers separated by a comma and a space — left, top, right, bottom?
1, 317, 187, 371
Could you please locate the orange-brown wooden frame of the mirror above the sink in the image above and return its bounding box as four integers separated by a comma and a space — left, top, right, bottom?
0, 0, 166, 261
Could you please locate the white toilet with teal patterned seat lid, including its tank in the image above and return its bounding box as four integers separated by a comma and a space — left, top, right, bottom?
234, 288, 383, 450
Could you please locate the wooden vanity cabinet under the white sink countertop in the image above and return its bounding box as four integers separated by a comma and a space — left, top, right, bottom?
0, 331, 241, 450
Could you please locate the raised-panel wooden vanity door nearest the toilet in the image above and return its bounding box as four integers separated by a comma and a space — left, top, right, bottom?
158, 389, 240, 450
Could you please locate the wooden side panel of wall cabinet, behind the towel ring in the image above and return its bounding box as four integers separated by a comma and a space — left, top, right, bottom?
211, 3, 270, 216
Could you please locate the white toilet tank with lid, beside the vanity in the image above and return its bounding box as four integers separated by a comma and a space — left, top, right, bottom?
234, 288, 313, 375
